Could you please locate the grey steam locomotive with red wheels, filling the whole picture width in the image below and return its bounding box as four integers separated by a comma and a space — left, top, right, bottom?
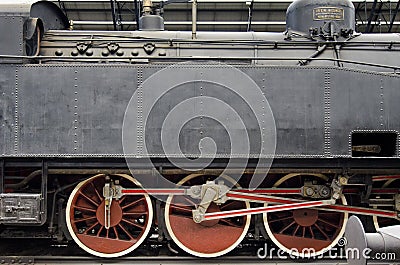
0, 0, 400, 257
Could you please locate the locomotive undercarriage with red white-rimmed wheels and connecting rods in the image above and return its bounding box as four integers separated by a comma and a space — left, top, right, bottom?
0, 159, 400, 257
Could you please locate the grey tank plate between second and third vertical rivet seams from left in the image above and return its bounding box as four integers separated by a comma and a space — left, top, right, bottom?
74, 65, 138, 155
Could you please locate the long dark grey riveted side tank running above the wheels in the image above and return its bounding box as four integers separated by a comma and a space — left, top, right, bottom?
5, 65, 400, 158
